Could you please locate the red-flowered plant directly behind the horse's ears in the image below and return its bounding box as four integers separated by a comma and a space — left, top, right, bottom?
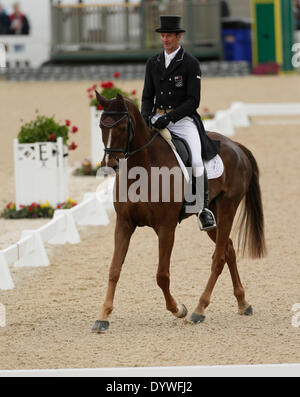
87, 72, 139, 110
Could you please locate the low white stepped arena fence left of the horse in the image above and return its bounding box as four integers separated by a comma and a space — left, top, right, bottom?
0, 177, 115, 290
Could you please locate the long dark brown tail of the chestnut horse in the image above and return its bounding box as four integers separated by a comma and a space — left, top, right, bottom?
238, 144, 267, 258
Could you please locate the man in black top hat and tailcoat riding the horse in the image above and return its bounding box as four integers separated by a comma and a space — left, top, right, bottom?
141, 16, 219, 230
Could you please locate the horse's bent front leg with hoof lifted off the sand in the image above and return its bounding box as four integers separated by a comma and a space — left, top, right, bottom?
156, 227, 187, 318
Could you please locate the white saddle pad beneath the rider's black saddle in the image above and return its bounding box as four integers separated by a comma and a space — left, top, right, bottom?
160, 128, 224, 181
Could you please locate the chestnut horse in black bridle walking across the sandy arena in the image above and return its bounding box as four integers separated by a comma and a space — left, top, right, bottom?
92, 91, 266, 333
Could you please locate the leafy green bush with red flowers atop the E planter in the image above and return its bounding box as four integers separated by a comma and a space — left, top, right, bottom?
18, 111, 78, 150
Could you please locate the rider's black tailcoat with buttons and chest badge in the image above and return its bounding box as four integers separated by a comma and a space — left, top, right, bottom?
141, 47, 219, 160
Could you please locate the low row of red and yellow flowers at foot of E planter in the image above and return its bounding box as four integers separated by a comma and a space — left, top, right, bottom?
1, 198, 77, 219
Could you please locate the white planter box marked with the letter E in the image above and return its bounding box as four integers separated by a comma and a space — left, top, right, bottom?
14, 138, 69, 209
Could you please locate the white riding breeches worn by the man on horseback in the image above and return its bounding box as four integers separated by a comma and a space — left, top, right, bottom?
152, 114, 204, 177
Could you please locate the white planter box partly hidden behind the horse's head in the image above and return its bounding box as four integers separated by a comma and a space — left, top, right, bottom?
91, 106, 104, 167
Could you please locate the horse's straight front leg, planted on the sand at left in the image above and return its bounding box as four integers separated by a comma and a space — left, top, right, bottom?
92, 219, 135, 333
